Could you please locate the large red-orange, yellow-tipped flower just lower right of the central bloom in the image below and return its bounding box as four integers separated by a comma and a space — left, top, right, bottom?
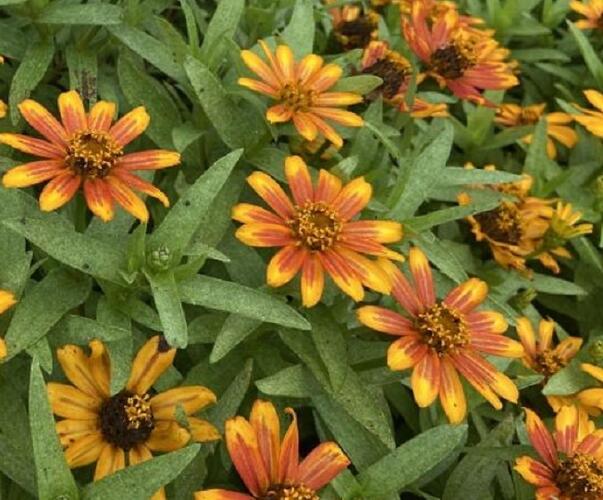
357, 247, 524, 423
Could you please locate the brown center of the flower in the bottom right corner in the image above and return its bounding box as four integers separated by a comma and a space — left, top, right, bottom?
555, 453, 603, 500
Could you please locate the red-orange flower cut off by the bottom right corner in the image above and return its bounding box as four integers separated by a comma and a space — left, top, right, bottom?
515, 406, 603, 500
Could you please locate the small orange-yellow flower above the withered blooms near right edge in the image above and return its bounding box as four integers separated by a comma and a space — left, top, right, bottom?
495, 104, 578, 158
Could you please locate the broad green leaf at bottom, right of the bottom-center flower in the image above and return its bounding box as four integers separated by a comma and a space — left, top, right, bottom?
357, 424, 467, 498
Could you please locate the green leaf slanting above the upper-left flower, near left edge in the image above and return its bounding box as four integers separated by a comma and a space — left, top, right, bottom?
8, 40, 54, 125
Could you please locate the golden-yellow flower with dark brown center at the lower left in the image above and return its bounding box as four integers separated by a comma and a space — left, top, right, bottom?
48, 336, 220, 494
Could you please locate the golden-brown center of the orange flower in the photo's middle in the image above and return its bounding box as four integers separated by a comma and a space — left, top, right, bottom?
290, 202, 343, 250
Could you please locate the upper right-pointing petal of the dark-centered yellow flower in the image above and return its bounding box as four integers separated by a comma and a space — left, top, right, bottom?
151, 385, 216, 420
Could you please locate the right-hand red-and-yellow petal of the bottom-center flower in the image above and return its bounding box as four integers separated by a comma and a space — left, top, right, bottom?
298, 442, 350, 491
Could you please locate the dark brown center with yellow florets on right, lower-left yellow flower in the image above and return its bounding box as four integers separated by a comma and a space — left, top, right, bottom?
100, 391, 155, 451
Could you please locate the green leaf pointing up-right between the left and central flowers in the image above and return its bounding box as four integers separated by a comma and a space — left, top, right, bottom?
149, 149, 243, 255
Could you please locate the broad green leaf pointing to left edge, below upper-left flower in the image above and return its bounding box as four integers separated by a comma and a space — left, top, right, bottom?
2, 217, 125, 284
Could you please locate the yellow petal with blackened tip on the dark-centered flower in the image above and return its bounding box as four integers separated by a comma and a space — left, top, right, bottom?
126, 335, 176, 394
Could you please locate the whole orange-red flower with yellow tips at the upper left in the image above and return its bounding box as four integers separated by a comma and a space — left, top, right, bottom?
0, 90, 180, 222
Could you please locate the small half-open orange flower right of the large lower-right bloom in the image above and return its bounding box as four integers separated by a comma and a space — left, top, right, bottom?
516, 317, 582, 380
